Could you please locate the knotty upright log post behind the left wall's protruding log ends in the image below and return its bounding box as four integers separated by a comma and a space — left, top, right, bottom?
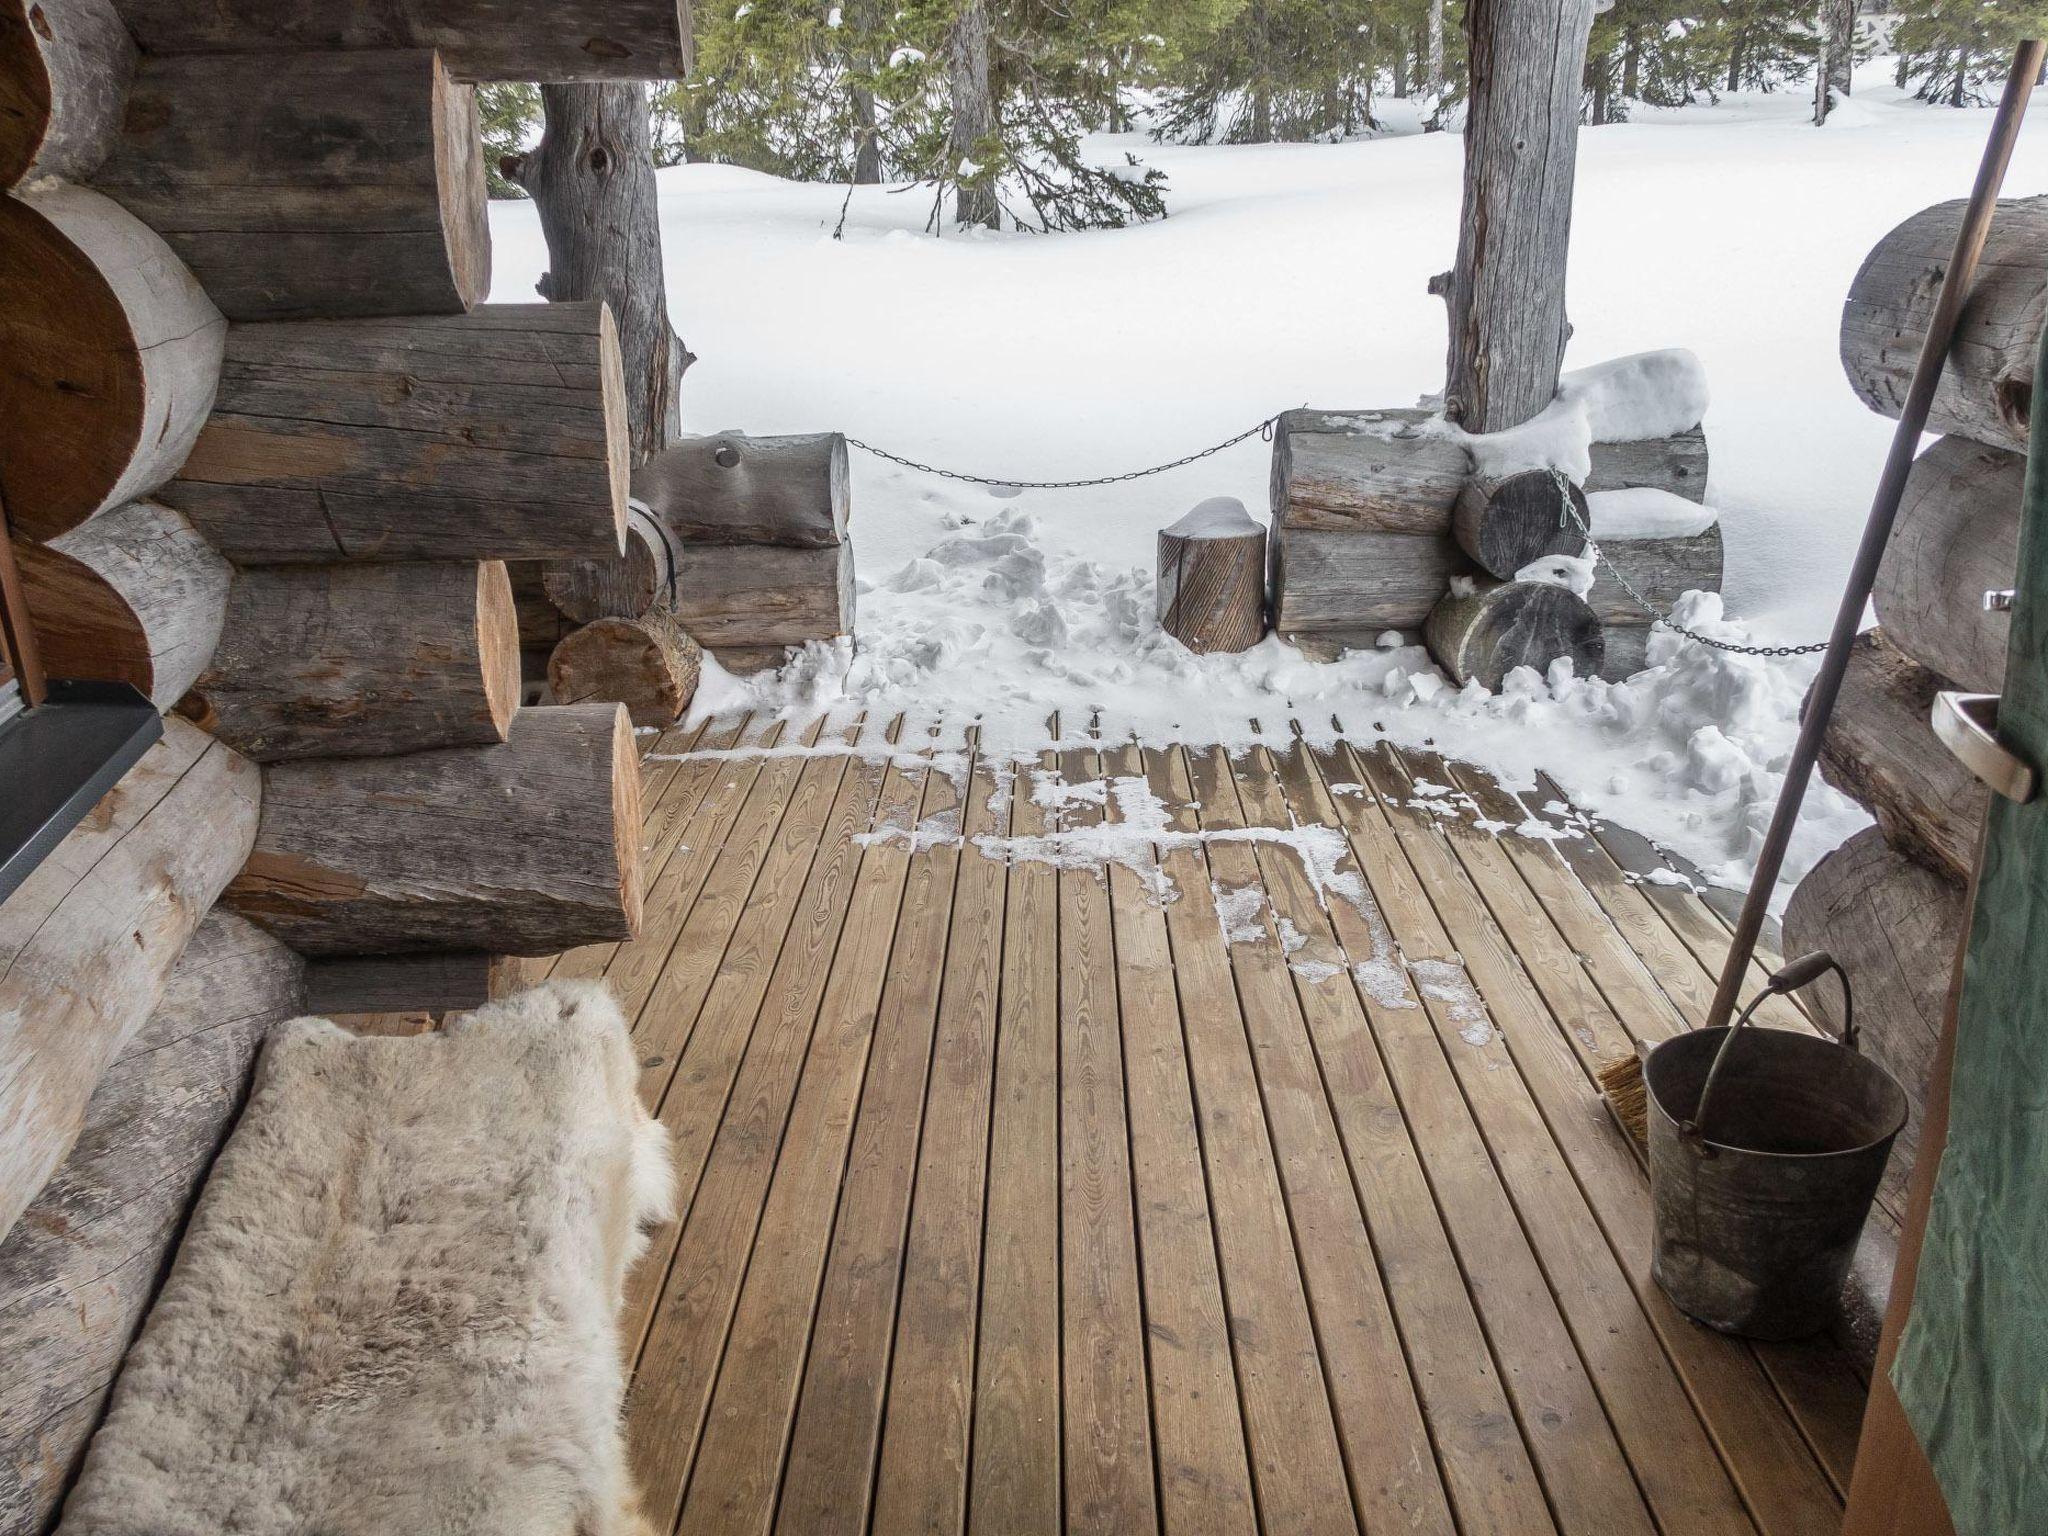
502, 82, 696, 463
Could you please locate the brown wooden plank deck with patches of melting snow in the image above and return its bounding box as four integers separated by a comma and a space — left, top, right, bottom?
520, 721, 1864, 1536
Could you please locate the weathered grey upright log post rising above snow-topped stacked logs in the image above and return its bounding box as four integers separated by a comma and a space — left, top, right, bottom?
1444, 0, 1593, 432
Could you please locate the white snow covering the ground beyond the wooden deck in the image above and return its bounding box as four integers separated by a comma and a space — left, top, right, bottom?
492, 72, 2048, 909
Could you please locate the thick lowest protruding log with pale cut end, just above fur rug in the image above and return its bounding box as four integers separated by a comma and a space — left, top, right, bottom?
225, 705, 641, 954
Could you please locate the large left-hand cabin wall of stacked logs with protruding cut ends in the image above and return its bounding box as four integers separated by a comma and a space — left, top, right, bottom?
0, 0, 688, 1530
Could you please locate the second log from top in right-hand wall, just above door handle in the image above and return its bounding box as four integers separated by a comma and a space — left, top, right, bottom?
1870, 438, 2028, 694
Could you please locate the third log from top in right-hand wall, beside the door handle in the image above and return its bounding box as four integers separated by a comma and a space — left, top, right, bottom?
1821, 631, 1991, 885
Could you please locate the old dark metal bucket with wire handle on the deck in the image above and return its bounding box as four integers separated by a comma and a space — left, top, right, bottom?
1642, 954, 1907, 1339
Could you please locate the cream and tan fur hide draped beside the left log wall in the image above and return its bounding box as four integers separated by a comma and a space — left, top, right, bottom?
59, 983, 674, 1536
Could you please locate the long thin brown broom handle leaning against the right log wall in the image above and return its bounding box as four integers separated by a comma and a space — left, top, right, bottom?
1706, 41, 2044, 1028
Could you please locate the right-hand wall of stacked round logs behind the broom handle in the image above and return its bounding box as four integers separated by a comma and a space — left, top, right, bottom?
1784, 199, 2048, 1220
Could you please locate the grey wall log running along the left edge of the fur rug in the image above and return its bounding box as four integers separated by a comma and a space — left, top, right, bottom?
0, 911, 305, 1532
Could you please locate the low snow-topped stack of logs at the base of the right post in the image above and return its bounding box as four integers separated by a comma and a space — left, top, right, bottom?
1272, 410, 1720, 686
